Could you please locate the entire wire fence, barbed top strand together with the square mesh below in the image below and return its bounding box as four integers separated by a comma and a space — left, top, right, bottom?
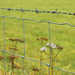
0, 8, 75, 75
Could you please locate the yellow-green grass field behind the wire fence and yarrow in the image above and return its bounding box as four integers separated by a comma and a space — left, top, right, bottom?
0, 0, 75, 75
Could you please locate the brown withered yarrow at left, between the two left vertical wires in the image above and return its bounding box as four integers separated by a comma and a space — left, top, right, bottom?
9, 38, 24, 75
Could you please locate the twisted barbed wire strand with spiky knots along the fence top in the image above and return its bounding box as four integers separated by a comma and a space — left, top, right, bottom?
0, 8, 75, 15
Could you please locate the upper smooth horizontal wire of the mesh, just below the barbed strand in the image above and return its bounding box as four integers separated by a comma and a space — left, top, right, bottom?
0, 15, 75, 27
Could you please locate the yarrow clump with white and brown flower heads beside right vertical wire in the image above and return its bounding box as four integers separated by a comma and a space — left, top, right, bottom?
37, 37, 63, 75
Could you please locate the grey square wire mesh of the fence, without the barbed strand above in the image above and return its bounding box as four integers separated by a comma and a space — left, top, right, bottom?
0, 13, 75, 75
